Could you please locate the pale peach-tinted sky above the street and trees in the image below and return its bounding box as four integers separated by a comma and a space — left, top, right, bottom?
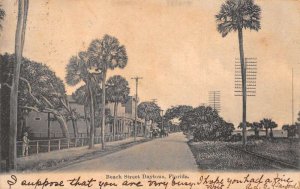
0, 0, 300, 128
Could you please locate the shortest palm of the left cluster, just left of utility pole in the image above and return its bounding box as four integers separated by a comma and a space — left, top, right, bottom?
106, 75, 130, 138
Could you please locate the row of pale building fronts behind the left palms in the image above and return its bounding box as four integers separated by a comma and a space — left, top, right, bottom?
25, 96, 144, 138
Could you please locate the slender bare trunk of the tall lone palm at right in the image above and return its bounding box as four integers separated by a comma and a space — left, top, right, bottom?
238, 28, 247, 146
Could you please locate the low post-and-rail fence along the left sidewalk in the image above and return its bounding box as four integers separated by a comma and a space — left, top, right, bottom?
17, 133, 129, 157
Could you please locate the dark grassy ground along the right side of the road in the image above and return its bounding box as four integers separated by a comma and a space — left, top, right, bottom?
189, 141, 294, 171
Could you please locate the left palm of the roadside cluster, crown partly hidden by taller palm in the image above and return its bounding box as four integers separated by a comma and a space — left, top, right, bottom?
65, 52, 95, 148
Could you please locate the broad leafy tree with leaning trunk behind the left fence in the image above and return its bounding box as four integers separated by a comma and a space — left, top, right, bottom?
0, 54, 69, 137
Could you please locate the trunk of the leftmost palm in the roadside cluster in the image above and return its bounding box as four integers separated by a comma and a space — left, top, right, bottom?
87, 83, 95, 149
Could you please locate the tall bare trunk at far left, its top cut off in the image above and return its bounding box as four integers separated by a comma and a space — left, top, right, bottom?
8, 0, 29, 170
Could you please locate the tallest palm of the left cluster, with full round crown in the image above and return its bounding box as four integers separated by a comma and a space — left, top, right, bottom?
88, 35, 128, 149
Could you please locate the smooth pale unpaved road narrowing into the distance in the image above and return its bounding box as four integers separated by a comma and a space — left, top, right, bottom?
57, 133, 198, 172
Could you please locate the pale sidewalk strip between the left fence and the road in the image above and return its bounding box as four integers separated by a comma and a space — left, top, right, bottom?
17, 137, 150, 172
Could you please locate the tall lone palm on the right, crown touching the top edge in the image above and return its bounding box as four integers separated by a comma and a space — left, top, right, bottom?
216, 0, 261, 145
